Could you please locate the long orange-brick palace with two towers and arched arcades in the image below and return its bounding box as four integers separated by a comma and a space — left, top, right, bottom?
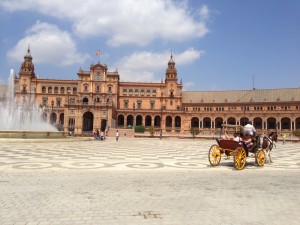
10, 49, 300, 135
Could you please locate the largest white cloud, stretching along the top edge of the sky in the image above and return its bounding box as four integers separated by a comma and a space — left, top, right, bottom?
0, 0, 210, 46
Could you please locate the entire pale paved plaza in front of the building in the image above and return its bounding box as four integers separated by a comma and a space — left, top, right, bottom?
0, 138, 300, 225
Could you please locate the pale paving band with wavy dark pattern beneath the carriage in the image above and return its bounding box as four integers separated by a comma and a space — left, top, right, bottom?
0, 138, 300, 171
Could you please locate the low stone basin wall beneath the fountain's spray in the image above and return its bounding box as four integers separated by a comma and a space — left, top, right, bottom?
0, 130, 68, 139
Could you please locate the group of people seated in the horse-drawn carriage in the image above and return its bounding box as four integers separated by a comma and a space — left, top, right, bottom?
222, 124, 256, 149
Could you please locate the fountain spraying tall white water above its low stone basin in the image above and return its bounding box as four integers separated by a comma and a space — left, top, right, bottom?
0, 69, 66, 138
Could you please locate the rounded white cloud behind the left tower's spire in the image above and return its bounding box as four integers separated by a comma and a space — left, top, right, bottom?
7, 21, 90, 66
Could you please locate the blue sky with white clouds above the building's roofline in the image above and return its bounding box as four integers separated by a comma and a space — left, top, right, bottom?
0, 0, 300, 91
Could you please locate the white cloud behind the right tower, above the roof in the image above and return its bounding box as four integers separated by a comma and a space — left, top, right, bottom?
116, 48, 204, 82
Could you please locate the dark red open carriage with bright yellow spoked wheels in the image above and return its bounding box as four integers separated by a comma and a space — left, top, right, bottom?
208, 124, 266, 170
